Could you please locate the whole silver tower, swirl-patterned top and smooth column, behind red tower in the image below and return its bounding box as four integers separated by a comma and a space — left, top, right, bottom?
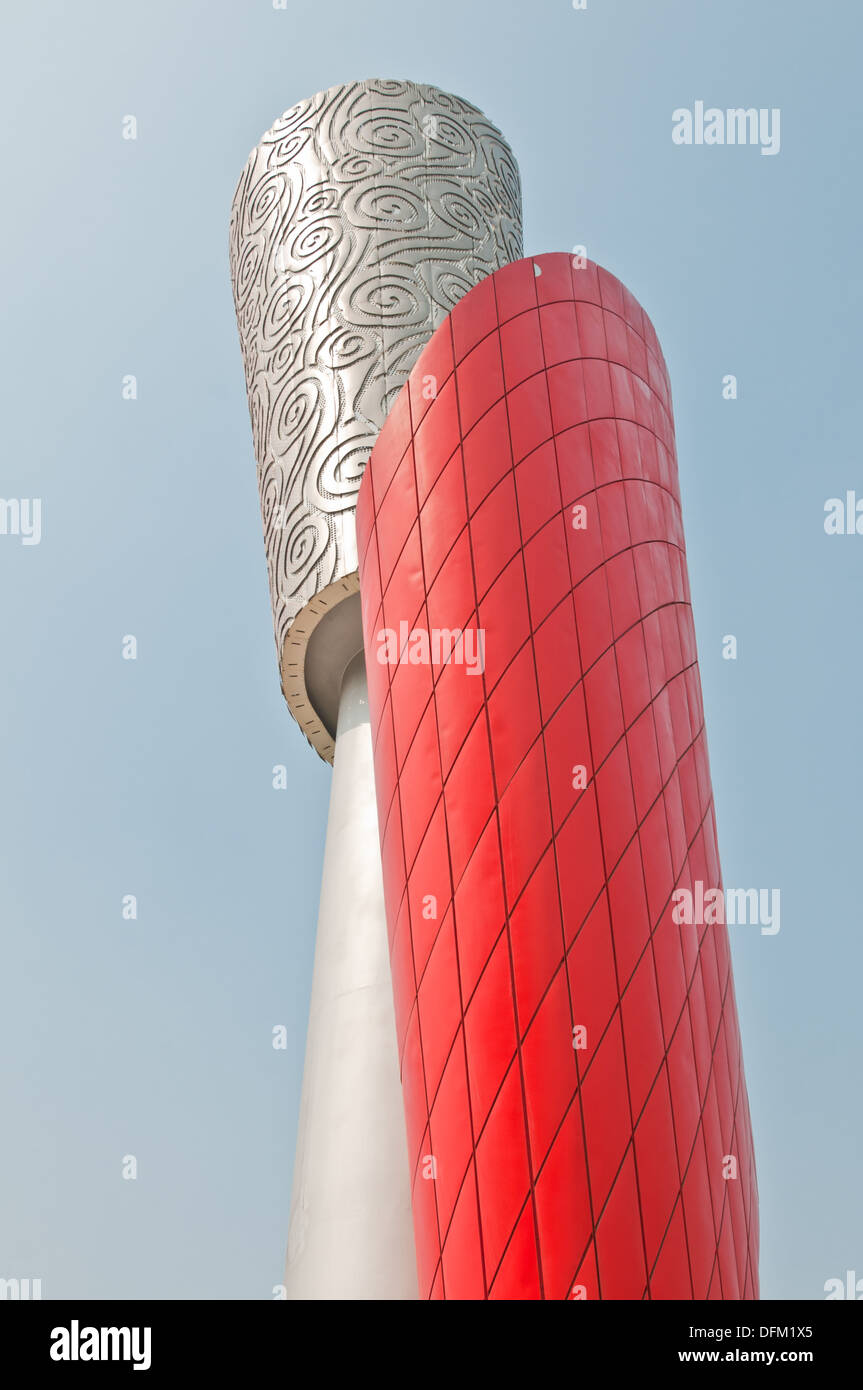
231, 79, 523, 1298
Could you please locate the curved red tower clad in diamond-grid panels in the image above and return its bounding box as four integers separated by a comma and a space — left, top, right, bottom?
357, 254, 757, 1298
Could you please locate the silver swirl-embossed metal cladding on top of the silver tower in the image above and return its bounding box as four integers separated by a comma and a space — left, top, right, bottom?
231, 79, 521, 678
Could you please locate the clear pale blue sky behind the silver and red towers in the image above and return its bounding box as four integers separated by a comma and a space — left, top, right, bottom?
0, 0, 863, 1298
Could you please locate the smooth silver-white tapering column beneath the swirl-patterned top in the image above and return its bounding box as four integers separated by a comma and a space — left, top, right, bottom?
285, 653, 418, 1298
